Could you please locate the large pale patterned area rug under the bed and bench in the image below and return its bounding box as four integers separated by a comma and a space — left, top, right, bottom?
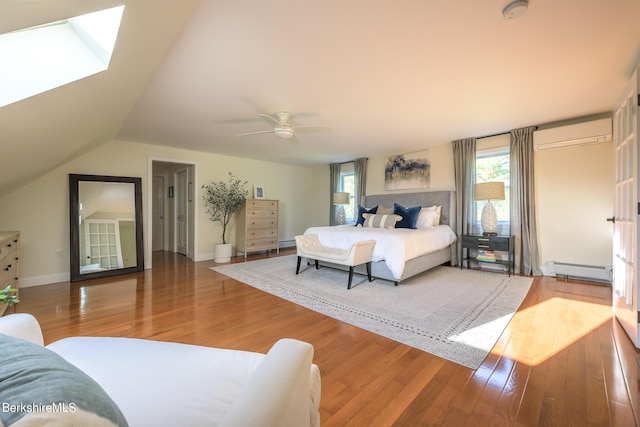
212, 255, 533, 369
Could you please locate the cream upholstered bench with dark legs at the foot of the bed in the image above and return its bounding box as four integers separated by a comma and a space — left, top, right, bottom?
295, 234, 376, 289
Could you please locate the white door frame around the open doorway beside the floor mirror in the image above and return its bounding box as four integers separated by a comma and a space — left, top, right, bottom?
144, 156, 200, 269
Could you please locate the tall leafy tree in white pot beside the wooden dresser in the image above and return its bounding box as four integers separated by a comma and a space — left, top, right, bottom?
202, 172, 249, 262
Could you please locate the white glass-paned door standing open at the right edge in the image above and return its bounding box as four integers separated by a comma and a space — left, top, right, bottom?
612, 63, 640, 348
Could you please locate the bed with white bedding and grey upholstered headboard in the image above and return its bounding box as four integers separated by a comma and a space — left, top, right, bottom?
305, 191, 457, 285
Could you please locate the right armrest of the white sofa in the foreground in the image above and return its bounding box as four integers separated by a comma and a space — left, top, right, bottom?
218, 338, 313, 427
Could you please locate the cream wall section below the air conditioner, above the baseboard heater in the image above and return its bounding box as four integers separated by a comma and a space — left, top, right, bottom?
535, 143, 614, 275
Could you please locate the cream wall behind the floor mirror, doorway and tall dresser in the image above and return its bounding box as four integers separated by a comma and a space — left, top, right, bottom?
0, 141, 314, 286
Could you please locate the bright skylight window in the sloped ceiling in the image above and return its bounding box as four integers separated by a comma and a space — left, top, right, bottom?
0, 6, 124, 107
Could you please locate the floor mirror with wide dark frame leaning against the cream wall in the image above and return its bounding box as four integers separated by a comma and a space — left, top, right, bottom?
69, 174, 144, 282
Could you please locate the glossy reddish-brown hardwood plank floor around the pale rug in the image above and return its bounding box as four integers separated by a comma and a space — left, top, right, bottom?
16, 249, 640, 426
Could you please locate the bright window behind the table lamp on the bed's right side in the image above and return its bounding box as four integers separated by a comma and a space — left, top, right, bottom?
476, 148, 510, 235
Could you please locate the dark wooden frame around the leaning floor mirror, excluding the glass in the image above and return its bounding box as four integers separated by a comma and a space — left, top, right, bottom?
69, 174, 144, 282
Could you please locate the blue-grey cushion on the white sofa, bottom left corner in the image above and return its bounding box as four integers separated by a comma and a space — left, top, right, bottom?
0, 334, 128, 426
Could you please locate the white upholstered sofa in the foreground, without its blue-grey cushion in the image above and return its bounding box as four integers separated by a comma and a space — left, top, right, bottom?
0, 314, 320, 427
